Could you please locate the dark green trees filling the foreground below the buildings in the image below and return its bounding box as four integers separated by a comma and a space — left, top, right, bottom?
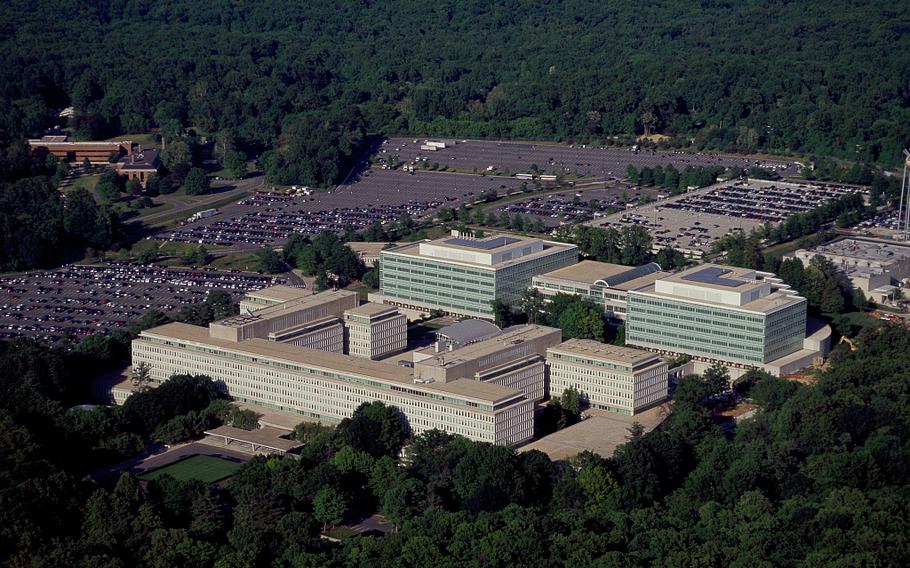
0, 312, 910, 568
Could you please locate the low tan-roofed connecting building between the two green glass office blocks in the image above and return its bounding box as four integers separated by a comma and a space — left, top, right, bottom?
531, 260, 668, 321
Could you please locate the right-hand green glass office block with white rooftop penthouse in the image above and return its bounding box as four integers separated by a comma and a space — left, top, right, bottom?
626, 264, 830, 373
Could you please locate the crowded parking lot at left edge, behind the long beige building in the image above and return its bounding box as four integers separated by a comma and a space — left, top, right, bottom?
0, 264, 285, 342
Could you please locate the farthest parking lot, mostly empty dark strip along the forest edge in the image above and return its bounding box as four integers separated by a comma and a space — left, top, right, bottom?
379, 138, 799, 179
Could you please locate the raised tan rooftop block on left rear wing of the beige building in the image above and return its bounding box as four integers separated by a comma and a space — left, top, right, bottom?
210, 288, 360, 341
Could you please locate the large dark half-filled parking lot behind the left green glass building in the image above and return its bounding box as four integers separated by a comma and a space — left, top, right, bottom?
157, 168, 520, 249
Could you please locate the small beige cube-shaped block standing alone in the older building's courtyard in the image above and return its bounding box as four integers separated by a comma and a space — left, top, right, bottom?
344, 303, 408, 359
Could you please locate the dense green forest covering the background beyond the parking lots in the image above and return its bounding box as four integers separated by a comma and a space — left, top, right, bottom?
0, 0, 910, 184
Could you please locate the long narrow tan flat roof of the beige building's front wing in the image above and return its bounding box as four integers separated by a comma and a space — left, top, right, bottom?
139, 322, 520, 404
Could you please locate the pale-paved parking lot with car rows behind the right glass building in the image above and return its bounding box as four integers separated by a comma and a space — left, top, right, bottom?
589, 180, 856, 257
